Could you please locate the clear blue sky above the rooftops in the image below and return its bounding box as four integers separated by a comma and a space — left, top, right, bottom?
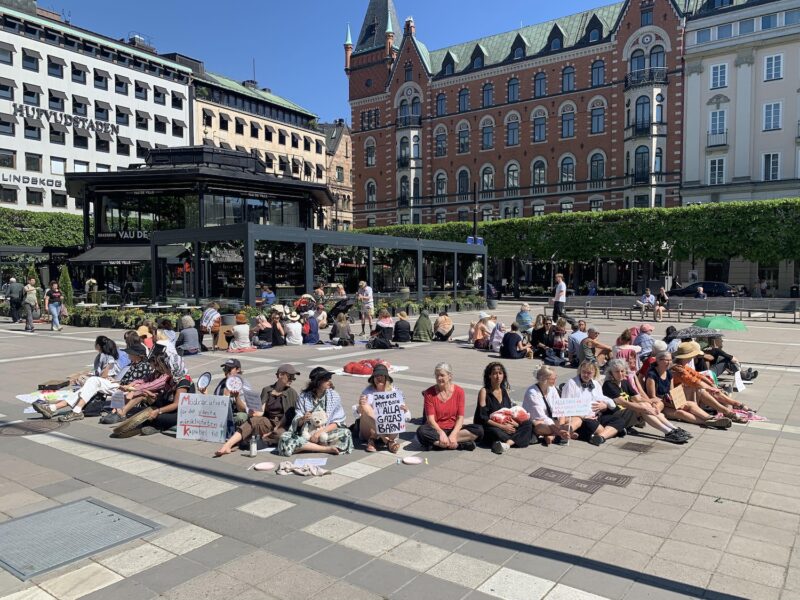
56, 0, 613, 122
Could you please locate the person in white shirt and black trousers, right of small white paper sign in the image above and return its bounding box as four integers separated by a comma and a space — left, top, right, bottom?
561, 360, 626, 446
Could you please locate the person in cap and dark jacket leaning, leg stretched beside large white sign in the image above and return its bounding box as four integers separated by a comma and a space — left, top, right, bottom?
214, 363, 300, 456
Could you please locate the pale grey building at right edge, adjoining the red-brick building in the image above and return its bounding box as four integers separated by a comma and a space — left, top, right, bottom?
679, 0, 800, 294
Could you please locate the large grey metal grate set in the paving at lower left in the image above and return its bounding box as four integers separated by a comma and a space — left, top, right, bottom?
0, 498, 159, 581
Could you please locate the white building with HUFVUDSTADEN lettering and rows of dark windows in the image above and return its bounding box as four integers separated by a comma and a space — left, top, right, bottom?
0, 0, 192, 214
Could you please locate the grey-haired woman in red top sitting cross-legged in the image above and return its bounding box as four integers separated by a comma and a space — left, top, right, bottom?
417, 363, 483, 451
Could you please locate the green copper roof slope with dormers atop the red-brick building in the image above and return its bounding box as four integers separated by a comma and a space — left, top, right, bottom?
429, 2, 625, 73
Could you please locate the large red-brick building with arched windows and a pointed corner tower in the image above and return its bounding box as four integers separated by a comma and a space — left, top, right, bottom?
344, 0, 683, 227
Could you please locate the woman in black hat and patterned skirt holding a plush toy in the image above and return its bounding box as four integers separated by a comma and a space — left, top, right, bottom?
278, 367, 353, 456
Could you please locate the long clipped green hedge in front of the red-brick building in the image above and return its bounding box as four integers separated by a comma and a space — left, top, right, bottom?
358, 198, 800, 262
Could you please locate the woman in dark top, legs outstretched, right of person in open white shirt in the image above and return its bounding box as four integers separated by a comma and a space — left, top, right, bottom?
603, 358, 689, 444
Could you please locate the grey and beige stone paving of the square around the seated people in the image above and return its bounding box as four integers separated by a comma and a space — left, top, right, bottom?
0, 303, 800, 600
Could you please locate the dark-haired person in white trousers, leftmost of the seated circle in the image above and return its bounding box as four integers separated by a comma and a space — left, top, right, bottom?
31, 335, 120, 421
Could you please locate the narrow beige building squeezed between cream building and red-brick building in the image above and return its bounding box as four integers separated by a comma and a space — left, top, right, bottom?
320, 119, 353, 231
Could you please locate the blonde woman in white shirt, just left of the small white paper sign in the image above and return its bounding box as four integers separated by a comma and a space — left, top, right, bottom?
522, 365, 582, 446
